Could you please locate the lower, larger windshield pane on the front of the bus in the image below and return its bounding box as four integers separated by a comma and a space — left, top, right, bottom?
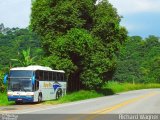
8, 78, 32, 92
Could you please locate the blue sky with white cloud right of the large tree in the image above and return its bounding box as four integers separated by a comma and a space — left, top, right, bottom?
109, 0, 160, 37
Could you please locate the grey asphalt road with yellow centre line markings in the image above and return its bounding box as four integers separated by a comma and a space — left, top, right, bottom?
0, 89, 160, 120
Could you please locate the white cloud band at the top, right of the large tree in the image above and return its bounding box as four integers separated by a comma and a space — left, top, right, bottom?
109, 0, 160, 15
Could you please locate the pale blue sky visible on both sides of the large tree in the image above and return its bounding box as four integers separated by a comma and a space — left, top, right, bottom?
0, 0, 160, 37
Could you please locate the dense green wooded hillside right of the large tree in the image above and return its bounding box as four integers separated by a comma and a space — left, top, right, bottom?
114, 36, 160, 83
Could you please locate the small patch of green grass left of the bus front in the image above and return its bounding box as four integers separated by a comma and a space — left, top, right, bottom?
0, 93, 14, 106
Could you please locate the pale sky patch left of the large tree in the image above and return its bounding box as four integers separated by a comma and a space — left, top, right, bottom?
0, 0, 31, 28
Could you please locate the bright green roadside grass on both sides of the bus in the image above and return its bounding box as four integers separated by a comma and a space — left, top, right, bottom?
0, 81, 160, 106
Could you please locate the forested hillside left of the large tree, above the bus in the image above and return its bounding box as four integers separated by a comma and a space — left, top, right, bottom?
0, 28, 42, 70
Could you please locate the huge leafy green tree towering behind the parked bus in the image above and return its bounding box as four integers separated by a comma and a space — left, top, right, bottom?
30, 0, 127, 89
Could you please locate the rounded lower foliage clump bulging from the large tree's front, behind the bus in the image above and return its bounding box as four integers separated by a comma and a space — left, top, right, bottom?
41, 29, 111, 89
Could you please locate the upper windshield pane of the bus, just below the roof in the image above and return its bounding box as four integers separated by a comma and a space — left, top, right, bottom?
10, 70, 33, 78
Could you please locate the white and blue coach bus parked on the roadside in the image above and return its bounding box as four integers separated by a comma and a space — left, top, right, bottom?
4, 66, 67, 103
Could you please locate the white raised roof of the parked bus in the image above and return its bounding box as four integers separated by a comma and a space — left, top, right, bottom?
10, 65, 65, 73
